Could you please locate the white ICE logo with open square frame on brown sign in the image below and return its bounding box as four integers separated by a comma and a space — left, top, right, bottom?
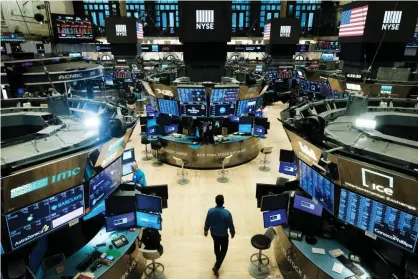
361, 168, 393, 196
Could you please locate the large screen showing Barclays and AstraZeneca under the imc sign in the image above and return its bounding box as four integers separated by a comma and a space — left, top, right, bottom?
6, 185, 85, 250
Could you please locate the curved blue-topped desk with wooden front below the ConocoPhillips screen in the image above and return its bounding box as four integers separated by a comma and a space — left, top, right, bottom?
274, 226, 371, 279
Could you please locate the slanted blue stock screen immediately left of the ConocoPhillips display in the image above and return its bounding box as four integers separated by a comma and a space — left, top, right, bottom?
299, 160, 334, 214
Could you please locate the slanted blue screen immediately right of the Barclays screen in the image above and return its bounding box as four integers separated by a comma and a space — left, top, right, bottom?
89, 158, 122, 210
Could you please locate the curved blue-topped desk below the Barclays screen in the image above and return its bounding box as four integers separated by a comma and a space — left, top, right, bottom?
44, 227, 146, 279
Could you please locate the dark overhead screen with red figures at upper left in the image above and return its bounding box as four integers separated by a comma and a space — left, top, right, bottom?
51, 14, 94, 42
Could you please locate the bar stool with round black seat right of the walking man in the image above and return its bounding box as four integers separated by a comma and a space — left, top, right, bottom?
248, 228, 276, 279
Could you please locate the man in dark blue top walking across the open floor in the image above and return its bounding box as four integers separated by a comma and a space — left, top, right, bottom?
204, 195, 235, 276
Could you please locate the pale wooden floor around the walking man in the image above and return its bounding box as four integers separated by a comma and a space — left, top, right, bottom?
128, 104, 292, 279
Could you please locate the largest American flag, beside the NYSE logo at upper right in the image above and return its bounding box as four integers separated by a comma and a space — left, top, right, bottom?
338, 6, 368, 37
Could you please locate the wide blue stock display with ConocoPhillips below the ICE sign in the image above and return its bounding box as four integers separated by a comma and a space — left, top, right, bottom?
338, 189, 418, 252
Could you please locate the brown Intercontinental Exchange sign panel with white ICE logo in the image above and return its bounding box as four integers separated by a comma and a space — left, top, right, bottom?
338, 157, 418, 216
